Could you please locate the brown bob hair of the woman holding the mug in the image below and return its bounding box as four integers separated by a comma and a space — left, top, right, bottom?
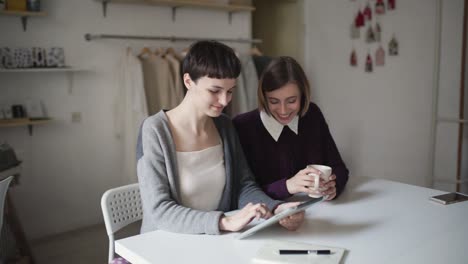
257, 56, 310, 116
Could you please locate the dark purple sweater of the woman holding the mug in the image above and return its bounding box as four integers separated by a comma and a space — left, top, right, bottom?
233, 103, 349, 200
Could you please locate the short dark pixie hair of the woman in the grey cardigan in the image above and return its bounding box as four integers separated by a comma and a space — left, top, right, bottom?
181, 40, 241, 82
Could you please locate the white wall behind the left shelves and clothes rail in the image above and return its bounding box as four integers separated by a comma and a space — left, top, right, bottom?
0, 0, 251, 238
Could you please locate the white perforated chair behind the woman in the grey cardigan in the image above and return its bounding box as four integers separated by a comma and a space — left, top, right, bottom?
101, 183, 143, 263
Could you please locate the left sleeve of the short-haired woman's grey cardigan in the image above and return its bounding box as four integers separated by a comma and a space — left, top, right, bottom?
137, 118, 223, 234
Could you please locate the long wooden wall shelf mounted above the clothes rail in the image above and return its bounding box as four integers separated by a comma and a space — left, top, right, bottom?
95, 0, 255, 23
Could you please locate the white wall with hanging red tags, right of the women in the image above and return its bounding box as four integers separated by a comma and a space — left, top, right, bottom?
305, 0, 463, 189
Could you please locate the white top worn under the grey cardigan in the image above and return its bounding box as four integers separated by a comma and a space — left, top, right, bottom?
177, 144, 226, 211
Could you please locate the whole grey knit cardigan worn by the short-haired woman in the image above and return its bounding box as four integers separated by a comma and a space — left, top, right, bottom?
137, 111, 281, 234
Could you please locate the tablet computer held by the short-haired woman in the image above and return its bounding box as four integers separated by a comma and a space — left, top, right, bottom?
237, 197, 325, 239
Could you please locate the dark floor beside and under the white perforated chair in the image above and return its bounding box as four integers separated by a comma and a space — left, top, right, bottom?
31, 223, 140, 264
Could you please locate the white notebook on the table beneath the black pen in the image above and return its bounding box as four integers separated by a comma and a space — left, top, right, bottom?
252, 240, 346, 264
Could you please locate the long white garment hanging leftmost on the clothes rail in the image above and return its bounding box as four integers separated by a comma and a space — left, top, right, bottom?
114, 48, 148, 184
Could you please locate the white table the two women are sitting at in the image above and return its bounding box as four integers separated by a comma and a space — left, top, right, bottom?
115, 177, 468, 264
